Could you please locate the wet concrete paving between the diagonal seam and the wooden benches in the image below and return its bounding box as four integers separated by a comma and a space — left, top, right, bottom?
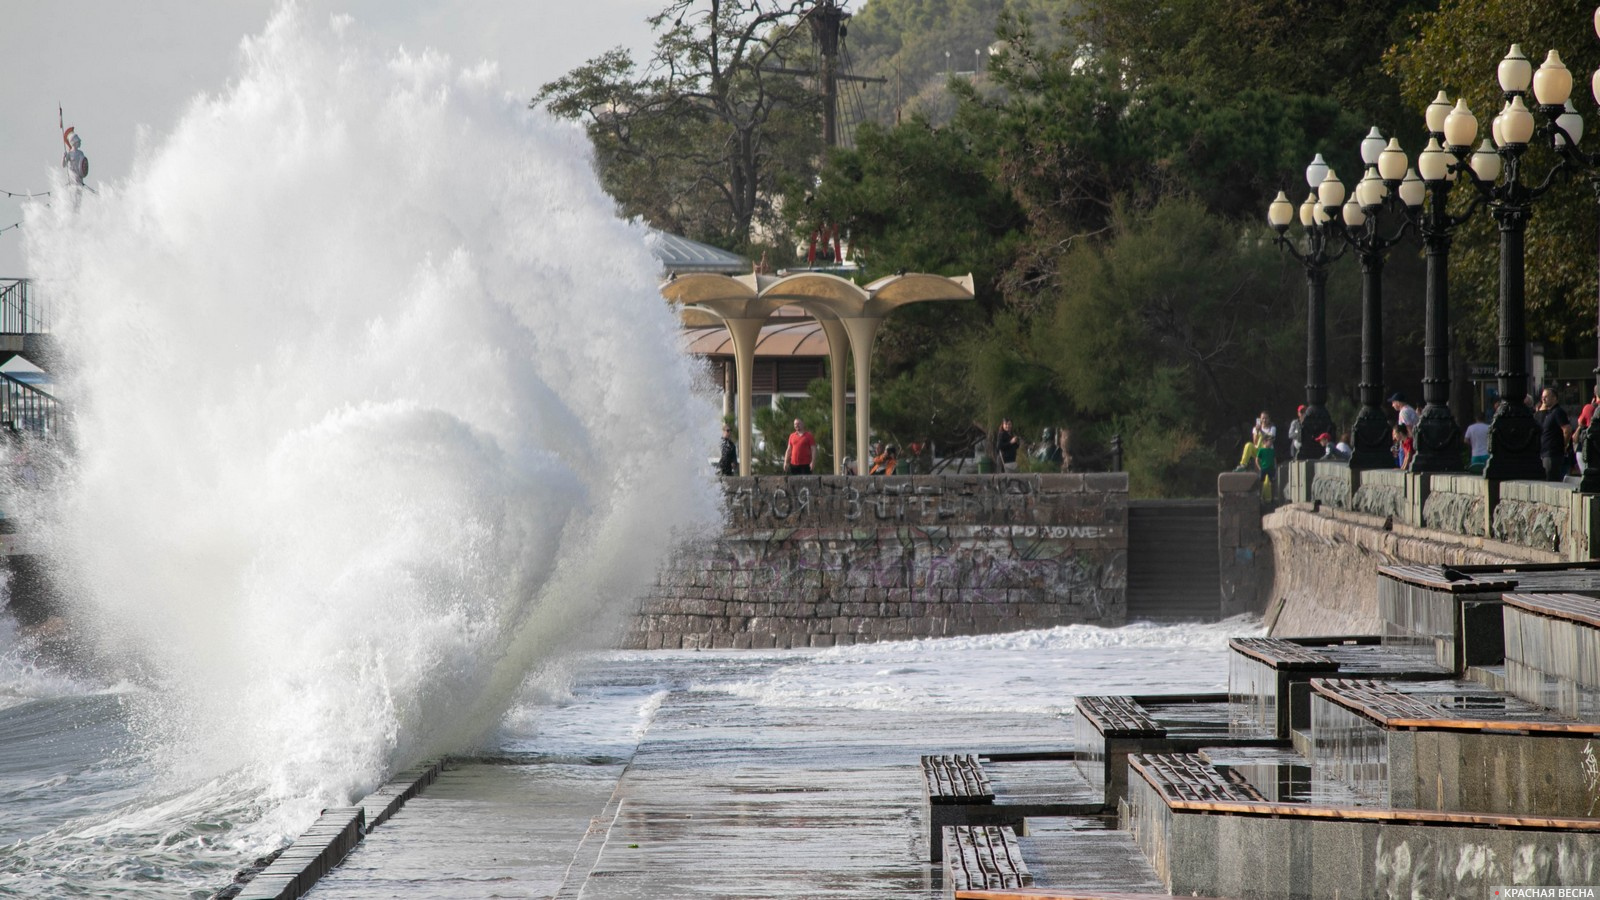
581, 693, 1070, 900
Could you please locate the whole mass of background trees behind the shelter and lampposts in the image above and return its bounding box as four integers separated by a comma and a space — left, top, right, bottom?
539, 0, 1600, 495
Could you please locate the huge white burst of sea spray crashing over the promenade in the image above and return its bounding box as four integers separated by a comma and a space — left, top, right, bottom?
12, 5, 717, 828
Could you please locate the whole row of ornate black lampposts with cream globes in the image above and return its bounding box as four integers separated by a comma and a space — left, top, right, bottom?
1267, 10, 1600, 492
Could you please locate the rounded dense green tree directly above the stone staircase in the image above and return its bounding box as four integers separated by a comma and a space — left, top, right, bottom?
1030, 197, 1304, 495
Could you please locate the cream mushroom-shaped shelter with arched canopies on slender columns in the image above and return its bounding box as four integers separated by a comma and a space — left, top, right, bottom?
661, 272, 973, 476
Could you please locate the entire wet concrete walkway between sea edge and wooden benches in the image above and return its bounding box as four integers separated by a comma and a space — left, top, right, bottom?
310, 662, 1072, 900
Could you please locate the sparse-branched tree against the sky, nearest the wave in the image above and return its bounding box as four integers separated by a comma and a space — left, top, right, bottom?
533, 0, 821, 248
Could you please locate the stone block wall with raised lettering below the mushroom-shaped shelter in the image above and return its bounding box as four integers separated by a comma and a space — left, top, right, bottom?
624, 474, 1128, 649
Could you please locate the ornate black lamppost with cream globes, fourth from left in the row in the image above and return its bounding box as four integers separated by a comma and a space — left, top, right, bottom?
1443, 45, 1571, 480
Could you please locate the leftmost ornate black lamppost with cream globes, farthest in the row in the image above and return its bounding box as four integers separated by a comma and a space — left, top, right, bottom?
1267, 154, 1350, 460
